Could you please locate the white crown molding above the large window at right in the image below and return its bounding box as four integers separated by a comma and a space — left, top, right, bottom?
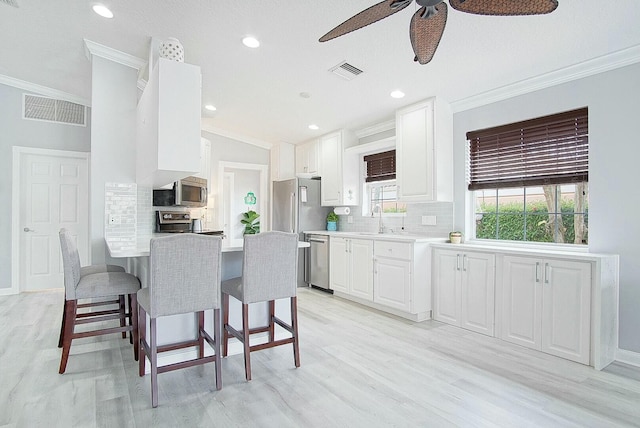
451, 45, 640, 113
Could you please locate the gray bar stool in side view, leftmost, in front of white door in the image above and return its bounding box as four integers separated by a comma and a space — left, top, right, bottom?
58, 228, 140, 374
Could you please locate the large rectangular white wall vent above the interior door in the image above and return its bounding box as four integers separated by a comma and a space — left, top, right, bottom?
23, 94, 86, 126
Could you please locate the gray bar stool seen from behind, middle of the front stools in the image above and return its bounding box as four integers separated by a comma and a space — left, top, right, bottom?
138, 234, 222, 407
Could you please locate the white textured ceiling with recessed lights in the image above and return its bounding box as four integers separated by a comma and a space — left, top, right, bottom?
0, 0, 640, 143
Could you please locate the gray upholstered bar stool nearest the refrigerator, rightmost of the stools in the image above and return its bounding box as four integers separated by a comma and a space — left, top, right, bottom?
222, 231, 300, 381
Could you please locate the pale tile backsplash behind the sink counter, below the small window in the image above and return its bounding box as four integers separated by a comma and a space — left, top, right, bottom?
338, 202, 453, 238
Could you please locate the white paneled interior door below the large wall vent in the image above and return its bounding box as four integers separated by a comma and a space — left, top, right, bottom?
14, 152, 89, 291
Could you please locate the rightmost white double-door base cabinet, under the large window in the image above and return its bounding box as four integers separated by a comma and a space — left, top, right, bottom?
501, 256, 591, 364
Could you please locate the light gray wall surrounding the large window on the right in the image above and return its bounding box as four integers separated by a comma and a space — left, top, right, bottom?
454, 64, 640, 352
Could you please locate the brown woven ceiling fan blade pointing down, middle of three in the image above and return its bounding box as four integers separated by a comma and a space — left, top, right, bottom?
409, 2, 447, 64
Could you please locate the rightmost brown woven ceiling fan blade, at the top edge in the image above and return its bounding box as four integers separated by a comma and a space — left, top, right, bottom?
449, 0, 558, 15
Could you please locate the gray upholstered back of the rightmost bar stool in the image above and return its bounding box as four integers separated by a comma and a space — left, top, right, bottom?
242, 232, 298, 303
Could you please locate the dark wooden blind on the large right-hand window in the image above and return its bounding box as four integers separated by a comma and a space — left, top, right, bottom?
467, 107, 589, 190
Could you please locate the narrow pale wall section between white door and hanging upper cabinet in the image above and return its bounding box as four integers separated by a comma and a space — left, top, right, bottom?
89, 55, 138, 264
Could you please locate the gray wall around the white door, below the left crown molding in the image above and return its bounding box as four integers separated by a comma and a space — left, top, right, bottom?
0, 84, 91, 289
